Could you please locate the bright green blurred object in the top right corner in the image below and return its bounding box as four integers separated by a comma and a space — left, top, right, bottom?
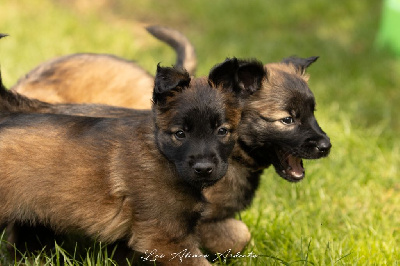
377, 0, 400, 56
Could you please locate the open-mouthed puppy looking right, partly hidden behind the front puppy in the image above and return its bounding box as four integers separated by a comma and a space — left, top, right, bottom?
3, 54, 331, 252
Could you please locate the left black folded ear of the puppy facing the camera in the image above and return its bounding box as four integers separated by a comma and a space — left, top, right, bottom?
153, 64, 190, 104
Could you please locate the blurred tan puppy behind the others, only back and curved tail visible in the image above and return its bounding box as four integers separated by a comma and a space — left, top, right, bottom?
12, 26, 196, 109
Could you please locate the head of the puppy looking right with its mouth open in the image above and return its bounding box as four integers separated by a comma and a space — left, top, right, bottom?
240, 57, 331, 182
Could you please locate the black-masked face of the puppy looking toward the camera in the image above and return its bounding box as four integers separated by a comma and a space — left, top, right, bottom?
153, 64, 241, 188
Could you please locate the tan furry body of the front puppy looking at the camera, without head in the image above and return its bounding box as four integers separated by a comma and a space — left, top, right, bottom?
0, 112, 207, 264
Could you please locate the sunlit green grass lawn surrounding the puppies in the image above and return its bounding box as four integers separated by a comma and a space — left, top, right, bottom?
0, 0, 400, 265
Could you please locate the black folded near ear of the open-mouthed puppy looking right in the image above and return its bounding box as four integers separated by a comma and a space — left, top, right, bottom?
237, 59, 267, 96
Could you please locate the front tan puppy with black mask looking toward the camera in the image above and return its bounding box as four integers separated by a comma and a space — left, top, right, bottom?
0, 59, 261, 265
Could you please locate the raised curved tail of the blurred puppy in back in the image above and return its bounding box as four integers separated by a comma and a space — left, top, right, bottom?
146, 26, 197, 76
